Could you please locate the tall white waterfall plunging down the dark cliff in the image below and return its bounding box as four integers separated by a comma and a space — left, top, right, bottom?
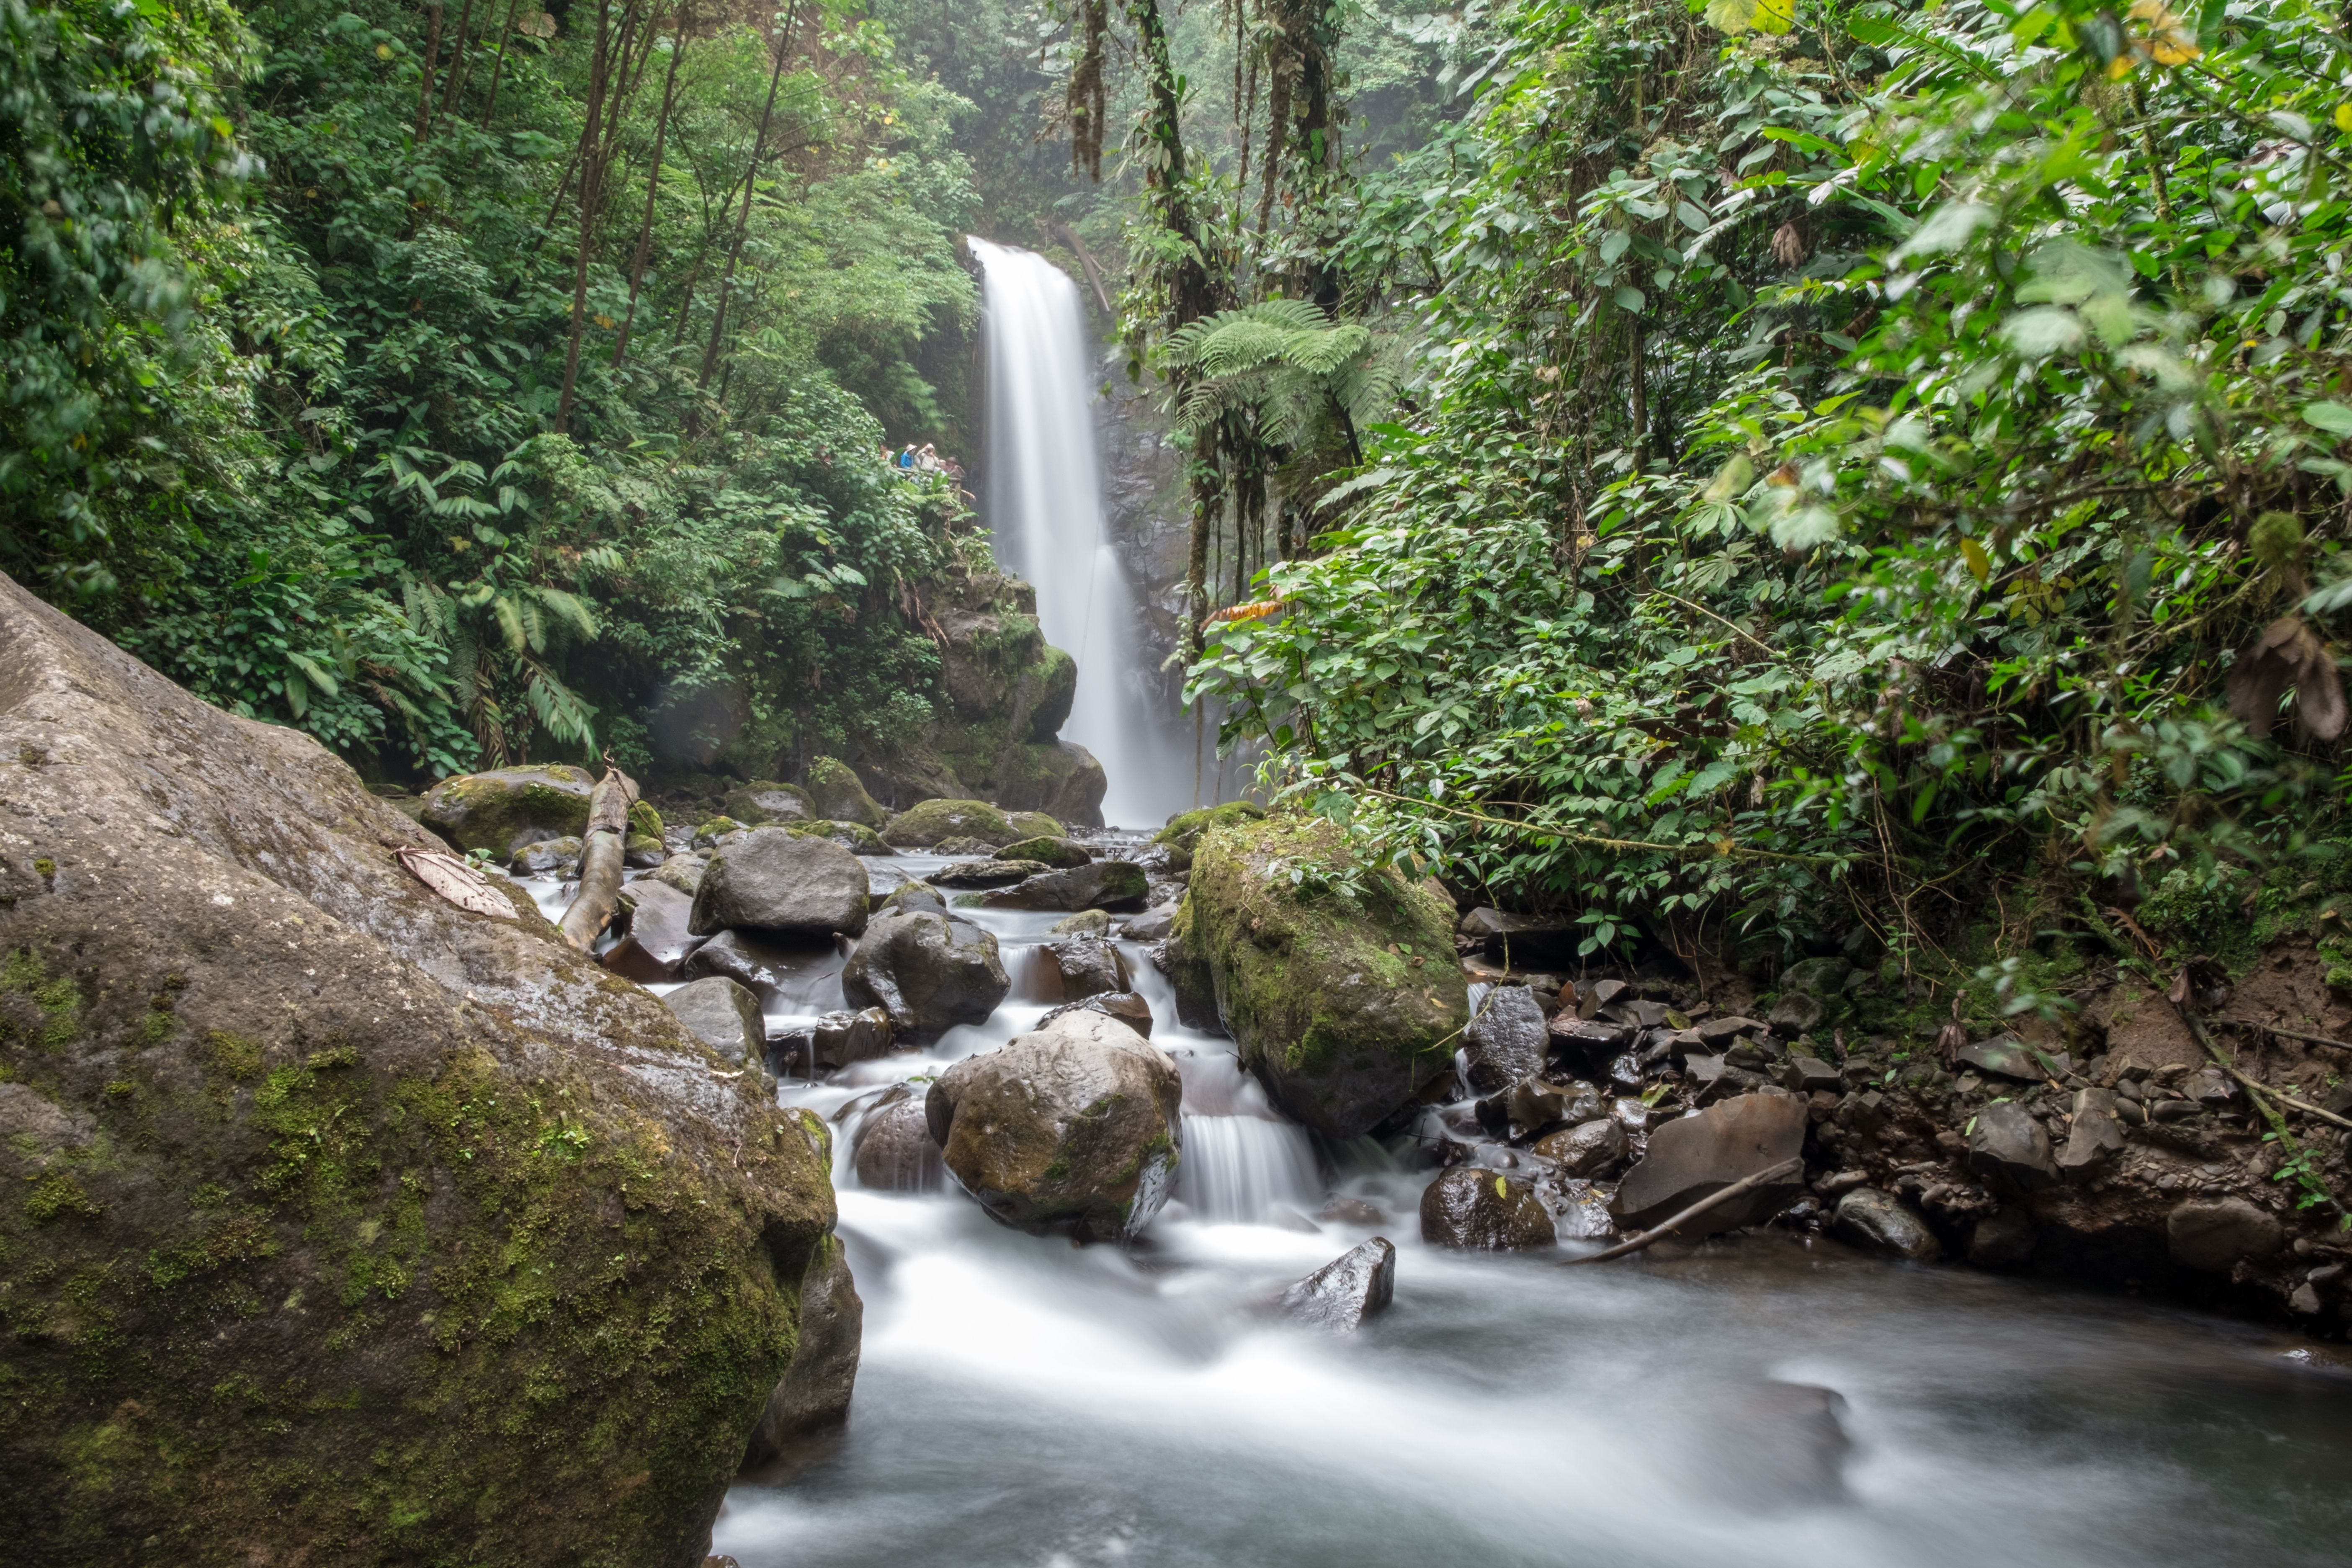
971, 240, 1195, 827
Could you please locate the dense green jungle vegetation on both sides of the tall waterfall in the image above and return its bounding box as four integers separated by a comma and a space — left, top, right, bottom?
13, 0, 2352, 978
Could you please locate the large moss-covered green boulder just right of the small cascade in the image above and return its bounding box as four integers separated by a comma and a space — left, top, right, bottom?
1169, 814, 1470, 1138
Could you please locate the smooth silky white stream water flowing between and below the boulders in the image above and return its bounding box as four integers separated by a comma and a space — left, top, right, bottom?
505, 856, 2352, 1568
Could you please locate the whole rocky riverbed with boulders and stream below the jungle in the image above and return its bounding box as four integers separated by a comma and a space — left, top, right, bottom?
13, 566, 2352, 1568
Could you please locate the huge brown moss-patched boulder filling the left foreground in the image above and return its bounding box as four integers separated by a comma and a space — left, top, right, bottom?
0, 578, 835, 1568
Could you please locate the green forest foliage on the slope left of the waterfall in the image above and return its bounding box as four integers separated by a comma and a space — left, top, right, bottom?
0, 0, 974, 773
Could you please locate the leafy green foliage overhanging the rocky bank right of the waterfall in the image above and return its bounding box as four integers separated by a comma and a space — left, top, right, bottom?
1193, 0, 2352, 964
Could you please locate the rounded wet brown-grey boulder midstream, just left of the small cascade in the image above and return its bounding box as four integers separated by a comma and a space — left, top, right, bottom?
924, 1009, 1183, 1241
